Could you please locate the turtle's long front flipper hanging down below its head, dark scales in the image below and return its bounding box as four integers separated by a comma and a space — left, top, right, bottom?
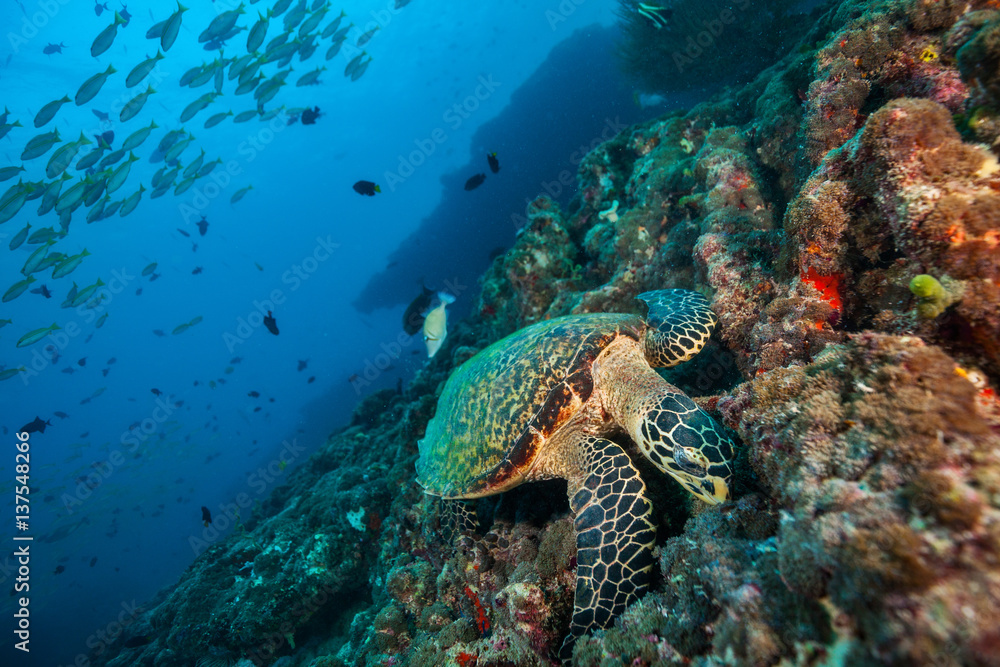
559, 436, 656, 660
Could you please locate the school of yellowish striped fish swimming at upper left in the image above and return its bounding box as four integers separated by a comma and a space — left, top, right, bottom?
0, 0, 409, 370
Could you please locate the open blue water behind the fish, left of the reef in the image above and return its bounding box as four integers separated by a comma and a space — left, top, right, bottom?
0, 0, 684, 665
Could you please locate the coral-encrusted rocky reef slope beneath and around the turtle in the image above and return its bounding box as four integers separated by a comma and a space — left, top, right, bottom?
93, 0, 1000, 667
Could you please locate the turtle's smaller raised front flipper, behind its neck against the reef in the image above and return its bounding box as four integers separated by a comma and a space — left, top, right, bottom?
636, 289, 719, 368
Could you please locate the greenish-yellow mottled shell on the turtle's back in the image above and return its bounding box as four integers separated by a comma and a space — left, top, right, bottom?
417, 313, 646, 498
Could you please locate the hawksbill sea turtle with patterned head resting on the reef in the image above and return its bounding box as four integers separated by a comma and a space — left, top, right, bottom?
417, 289, 733, 658
